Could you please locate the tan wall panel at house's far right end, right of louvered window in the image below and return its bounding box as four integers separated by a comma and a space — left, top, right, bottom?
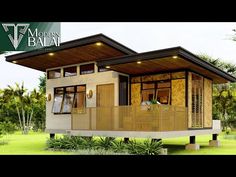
203, 78, 212, 127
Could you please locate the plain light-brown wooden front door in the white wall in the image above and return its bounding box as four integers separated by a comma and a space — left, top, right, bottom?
96, 84, 114, 130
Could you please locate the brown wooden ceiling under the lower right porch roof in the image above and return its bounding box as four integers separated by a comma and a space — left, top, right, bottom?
110, 57, 228, 83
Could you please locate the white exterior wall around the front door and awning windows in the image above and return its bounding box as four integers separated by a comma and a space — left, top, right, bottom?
46, 62, 128, 130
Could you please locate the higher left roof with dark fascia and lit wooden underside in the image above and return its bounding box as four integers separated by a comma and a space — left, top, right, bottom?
6, 34, 136, 72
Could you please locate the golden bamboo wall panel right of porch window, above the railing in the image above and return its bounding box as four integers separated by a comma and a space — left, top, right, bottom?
171, 79, 185, 107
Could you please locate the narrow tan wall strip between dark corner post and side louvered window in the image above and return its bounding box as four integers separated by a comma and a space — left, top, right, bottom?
188, 72, 192, 128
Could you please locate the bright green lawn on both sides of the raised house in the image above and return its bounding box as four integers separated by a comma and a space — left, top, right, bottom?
0, 132, 236, 155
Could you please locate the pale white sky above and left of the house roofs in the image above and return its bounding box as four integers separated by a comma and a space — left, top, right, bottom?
0, 22, 236, 90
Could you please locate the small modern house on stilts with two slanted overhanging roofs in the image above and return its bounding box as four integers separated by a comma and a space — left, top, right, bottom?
6, 34, 236, 149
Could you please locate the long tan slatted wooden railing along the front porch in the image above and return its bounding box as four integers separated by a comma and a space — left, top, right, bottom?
72, 105, 187, 131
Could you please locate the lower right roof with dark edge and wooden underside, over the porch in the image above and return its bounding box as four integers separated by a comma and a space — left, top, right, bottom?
97, 47, 236, 83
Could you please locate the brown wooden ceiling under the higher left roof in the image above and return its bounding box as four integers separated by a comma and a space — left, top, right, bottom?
10, 43, 125, 71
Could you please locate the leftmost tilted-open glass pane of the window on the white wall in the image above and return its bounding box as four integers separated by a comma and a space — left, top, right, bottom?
52, 88, 63, 113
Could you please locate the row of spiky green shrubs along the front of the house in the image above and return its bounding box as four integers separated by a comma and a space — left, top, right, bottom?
47, 136, 162, 155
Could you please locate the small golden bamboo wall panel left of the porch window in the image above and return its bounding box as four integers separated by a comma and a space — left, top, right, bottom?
131, 83, 141, 106
